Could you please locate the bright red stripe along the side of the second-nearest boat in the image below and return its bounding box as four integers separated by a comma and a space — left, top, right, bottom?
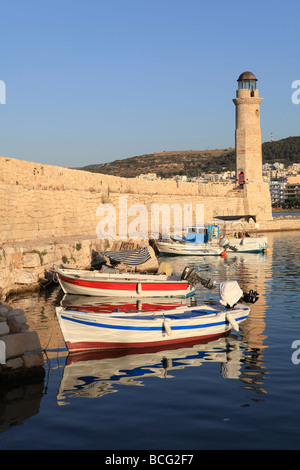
59, 275, 189, 292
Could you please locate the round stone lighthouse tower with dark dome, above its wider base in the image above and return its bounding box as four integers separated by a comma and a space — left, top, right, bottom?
233, 72, 262, 188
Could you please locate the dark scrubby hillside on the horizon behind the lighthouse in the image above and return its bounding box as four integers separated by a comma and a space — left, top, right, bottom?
80, 137, 300, 178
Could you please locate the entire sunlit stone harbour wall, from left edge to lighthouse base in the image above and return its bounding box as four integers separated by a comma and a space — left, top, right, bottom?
0, 157, 300, 301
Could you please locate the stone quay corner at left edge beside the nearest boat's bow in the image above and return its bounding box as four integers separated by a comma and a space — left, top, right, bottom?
0, 303, 44, 383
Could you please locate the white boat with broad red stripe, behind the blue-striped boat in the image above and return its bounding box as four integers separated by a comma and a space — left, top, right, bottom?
56, 268, 195, 297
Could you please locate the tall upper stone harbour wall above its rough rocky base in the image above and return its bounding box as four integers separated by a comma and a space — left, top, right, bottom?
0, 157, 271, 243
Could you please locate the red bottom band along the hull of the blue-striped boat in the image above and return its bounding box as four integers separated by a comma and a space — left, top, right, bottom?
66, 332, 228, 352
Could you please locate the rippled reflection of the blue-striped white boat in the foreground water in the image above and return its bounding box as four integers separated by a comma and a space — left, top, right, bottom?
57, 335, 245, 405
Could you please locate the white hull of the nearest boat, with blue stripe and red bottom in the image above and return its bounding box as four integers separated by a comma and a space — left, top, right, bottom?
56, 304, 250, 352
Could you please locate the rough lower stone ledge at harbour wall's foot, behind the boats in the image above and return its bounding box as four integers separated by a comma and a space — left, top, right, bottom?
0, 236, 148, 301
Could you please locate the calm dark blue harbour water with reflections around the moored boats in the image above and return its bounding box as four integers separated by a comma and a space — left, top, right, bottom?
0, 232, 300, 450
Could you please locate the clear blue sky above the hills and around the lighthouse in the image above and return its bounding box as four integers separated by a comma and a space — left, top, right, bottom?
0, 0, 300, 167
